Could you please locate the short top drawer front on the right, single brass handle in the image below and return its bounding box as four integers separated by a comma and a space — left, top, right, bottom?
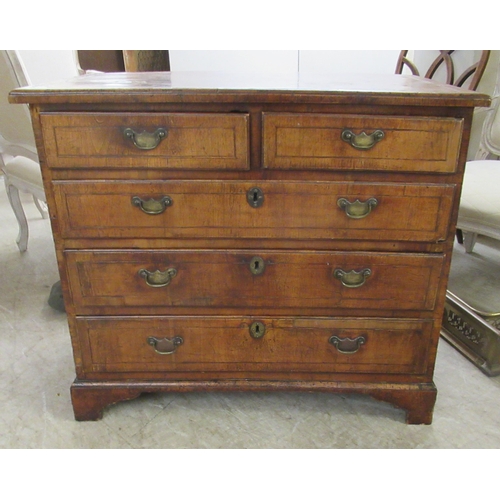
263, 113, 463, 173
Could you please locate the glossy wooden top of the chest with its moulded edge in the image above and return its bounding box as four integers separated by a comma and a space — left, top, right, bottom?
10, 71, 490, 107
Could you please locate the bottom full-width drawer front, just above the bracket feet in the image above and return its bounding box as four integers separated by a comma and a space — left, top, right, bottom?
77, 316, 432, 377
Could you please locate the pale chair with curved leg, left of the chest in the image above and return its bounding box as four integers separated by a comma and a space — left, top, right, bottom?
0, 50, 48, 252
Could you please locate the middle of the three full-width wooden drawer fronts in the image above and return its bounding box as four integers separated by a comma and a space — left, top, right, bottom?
65, 250, 443, 314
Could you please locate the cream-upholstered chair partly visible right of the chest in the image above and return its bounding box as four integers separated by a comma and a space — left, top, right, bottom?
457, 68, 500, 253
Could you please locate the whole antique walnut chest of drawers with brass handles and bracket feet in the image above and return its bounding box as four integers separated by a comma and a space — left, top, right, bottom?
11, 72, 488, 423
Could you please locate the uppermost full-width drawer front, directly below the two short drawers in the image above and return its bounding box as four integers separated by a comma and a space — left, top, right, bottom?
53, 181, 455, 243
